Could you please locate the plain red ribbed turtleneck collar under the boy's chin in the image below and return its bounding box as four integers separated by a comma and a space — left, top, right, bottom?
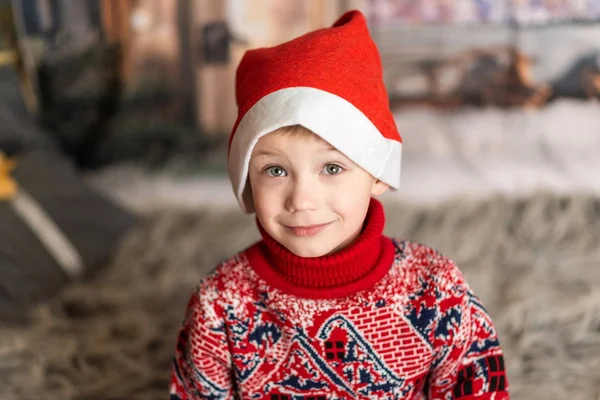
247, 199, 394, 298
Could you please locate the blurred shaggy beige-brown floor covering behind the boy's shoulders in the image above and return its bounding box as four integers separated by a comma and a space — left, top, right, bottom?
0, 194, 600, 400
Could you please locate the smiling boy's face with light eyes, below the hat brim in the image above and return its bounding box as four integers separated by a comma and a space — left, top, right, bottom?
248, 131, 388, 257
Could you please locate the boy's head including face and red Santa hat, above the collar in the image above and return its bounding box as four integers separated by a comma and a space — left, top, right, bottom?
228, 11, 402, 256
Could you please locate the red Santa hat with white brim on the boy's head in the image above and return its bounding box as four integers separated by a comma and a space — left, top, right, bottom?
228, 11, 402, 213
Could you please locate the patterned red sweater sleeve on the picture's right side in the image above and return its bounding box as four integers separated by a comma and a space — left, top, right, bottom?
429, 262, 510, 400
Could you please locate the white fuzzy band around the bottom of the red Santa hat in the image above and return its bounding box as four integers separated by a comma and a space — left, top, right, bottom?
228, 87, 402, 213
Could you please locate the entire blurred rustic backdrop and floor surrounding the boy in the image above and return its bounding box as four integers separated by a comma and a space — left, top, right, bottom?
0, 0, 600, 400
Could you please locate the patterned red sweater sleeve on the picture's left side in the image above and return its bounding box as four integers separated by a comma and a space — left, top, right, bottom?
170, 287, 234, 400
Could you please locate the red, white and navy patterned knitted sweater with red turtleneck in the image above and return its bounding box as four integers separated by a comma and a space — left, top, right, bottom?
170, 200, 509, 400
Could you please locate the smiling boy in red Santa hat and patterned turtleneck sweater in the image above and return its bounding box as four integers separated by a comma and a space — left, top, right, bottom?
171, 11, 509, 400
